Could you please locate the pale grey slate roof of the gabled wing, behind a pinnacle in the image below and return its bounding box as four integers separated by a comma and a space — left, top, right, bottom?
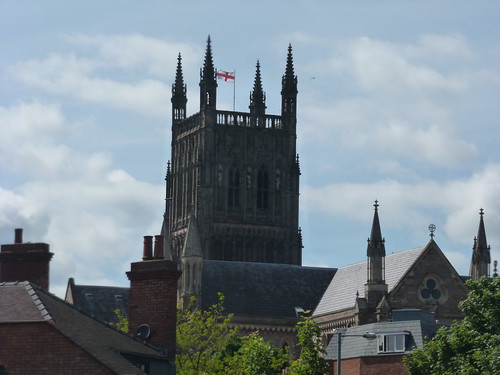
314, 247, 426, 316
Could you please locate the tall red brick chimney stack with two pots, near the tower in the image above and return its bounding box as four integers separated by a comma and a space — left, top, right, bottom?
127, 235, 180, 360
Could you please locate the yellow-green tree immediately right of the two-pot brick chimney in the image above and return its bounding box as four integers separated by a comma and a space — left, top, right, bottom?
176, 293, 237, 375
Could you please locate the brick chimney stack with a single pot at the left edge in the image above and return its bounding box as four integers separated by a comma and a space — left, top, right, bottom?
0, 228, 54, 290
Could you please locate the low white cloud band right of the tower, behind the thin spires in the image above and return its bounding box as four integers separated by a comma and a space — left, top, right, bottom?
301, 164, 500, 247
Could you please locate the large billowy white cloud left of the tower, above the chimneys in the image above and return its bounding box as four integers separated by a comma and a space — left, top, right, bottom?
0, 102, 164, 295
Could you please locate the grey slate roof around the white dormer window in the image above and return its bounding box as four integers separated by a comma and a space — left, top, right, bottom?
325, 320, 441, 361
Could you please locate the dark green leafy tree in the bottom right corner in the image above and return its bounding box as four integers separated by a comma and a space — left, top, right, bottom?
404, 277, 500, 375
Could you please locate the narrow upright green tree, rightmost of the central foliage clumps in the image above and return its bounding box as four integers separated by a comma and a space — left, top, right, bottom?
286, 317, 328, 375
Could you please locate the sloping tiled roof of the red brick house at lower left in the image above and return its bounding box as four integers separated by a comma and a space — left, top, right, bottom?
0, 281, 167, 374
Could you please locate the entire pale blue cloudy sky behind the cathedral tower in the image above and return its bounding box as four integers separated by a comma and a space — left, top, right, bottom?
0, 0, 500, 296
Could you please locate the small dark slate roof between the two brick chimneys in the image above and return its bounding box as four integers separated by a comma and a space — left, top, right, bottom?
65, 278, 129, 324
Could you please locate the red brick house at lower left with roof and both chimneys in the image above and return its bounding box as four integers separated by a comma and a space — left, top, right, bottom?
0, 230, 179, 375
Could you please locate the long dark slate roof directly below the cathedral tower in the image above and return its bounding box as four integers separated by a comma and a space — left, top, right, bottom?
201, 260, 336, 318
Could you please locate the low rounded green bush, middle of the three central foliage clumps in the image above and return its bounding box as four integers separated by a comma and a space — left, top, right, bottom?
228, 332, 288, 375
